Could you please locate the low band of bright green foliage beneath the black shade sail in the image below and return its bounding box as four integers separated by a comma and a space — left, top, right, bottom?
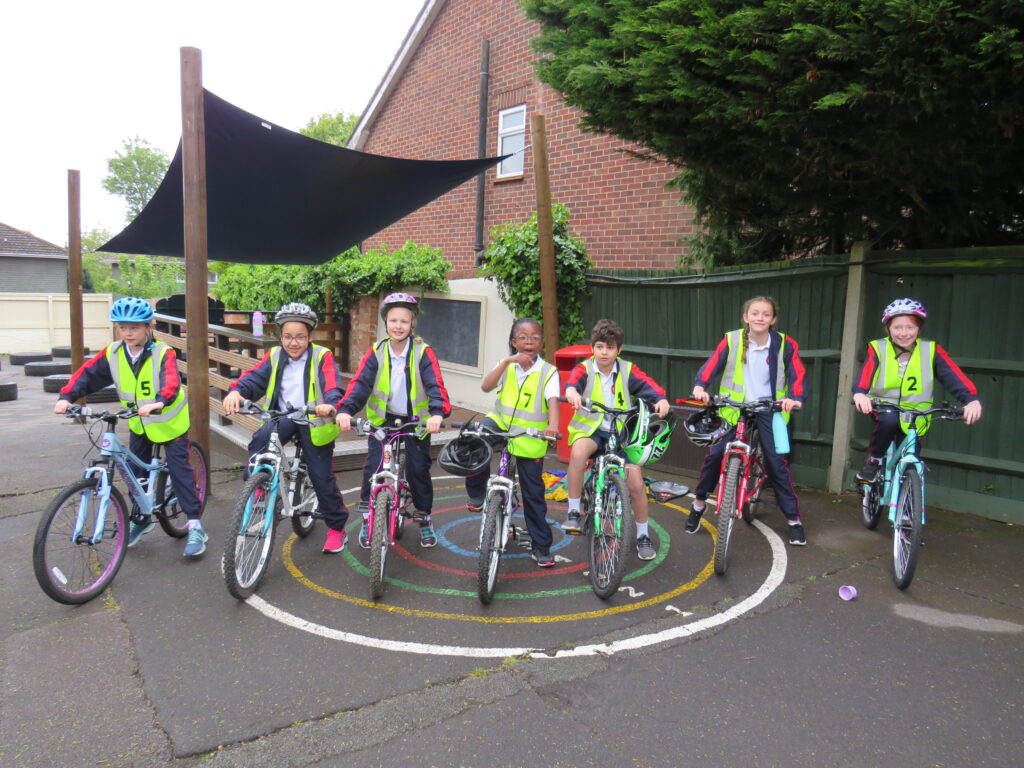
213, 241, 452, 312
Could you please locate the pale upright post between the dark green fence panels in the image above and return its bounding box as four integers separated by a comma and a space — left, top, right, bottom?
828, 241, 870, 494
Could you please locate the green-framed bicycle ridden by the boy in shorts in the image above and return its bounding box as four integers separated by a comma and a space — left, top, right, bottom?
558, 397, 640, 600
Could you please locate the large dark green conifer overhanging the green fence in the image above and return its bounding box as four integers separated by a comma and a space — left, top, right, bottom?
525, 0, 1024, 262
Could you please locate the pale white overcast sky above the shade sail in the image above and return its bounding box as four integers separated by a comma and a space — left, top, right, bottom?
0, 0, 423, 246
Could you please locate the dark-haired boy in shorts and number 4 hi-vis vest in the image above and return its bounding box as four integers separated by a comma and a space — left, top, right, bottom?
562, 319, 670, 560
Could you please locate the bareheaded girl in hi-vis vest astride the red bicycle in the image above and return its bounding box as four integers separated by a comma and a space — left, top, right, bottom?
685, 296, 807, 547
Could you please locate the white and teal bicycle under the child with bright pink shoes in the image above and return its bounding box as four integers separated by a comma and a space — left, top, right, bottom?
221, 400, 321, 600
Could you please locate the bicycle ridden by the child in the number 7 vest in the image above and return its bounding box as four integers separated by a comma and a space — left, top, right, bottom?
452, 422, 558, 605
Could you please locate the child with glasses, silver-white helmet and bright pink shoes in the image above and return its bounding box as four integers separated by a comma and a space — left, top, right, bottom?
224, 302, 348, 553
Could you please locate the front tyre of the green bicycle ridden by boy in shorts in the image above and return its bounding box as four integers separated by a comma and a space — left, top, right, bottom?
587, 472, 636, 600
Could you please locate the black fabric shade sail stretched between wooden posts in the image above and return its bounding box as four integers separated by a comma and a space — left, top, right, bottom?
99, 91, 502, 264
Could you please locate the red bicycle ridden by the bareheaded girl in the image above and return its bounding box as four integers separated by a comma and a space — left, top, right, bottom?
692, 395, 781, 575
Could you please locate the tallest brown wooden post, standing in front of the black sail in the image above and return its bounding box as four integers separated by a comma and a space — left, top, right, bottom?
180, 47, 210, 456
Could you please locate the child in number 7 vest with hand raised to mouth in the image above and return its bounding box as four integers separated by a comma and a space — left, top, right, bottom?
466, 317, 558, 568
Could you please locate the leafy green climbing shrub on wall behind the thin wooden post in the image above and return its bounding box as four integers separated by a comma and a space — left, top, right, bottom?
479, 204, 591, 345
